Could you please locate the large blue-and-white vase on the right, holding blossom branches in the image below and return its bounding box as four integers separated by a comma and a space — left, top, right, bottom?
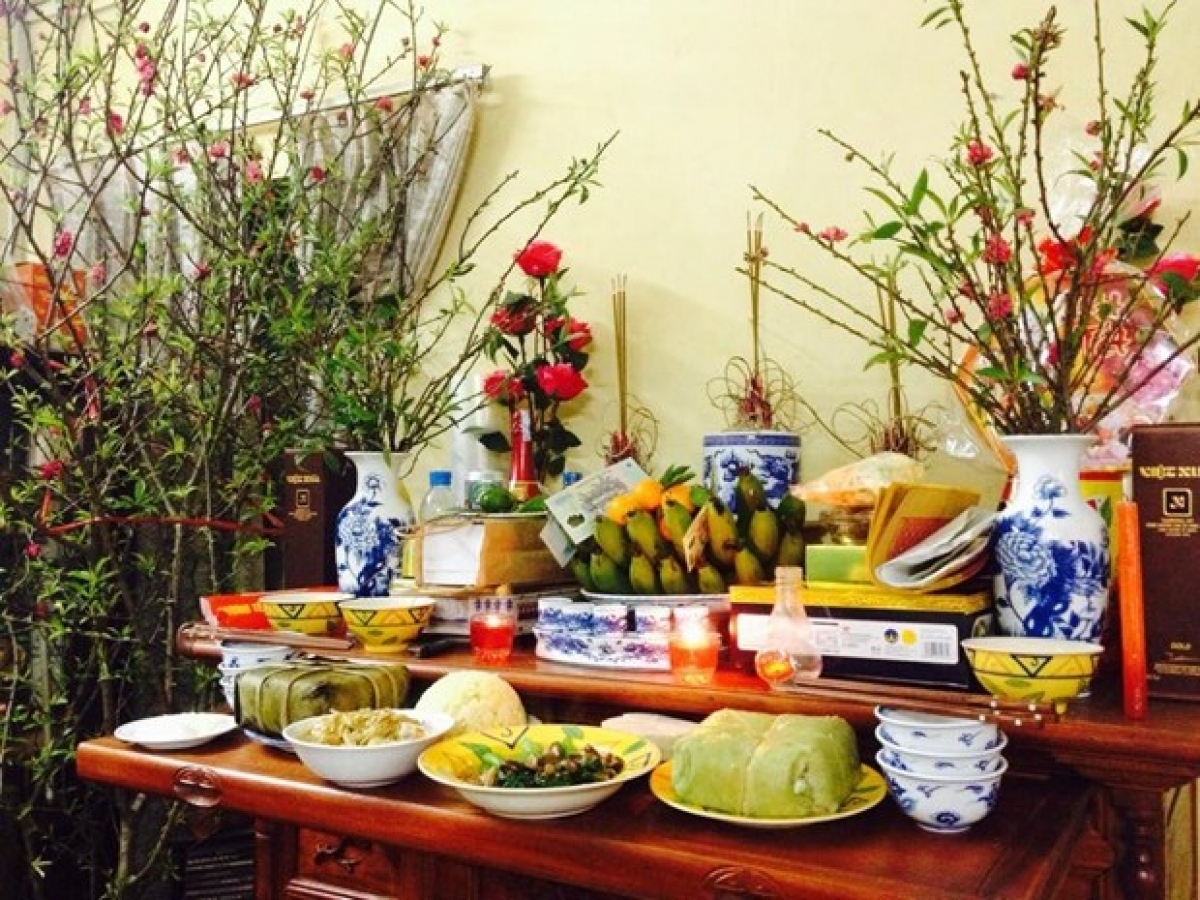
992, 434, 1111, 642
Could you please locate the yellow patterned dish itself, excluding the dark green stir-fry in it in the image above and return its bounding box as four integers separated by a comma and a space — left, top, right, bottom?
416, 725, 662, 818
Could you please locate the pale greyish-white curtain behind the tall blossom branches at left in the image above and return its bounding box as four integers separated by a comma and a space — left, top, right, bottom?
29, 78, 482, 303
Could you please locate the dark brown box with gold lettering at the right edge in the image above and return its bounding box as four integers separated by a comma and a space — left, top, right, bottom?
1117, 424, 1200, 700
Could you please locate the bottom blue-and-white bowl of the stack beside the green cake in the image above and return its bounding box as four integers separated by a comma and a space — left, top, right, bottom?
875, 750, 1008, 834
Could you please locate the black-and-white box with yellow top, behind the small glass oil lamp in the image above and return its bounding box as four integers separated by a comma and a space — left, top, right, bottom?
730, 582, 994, 690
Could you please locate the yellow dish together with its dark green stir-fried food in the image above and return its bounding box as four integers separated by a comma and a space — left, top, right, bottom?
418, 725, 662, 818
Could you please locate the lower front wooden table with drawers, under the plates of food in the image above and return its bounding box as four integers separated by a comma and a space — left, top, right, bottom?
78, 733, 1111, 900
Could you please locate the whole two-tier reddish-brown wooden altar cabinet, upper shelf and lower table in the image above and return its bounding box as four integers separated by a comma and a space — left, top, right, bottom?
93, 650, 1200, 900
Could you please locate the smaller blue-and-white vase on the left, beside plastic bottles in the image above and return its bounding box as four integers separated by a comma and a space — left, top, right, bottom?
334, 451, 416, 596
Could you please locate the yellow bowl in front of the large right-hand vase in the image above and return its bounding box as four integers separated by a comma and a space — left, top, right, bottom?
962, 637, 1104, 713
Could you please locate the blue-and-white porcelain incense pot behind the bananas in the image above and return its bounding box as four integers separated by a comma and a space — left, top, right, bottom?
701, 431, 800, 508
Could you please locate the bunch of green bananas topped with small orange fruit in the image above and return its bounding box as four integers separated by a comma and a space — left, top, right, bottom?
570, 467, 805, 595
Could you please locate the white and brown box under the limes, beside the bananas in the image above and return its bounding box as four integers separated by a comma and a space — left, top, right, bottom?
415, 514, 572, 588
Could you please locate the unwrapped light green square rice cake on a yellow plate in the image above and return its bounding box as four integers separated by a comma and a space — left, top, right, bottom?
671, 709, 860, 818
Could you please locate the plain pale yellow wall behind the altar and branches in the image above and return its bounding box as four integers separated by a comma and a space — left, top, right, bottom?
398, 0, 1200, 487
